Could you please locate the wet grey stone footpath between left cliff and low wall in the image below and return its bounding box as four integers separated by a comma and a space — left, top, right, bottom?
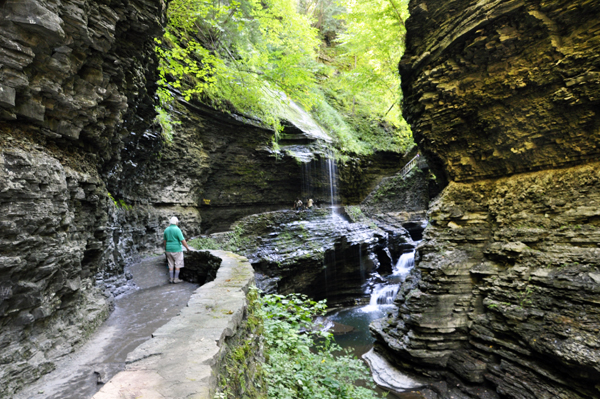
14, 255, 198, 399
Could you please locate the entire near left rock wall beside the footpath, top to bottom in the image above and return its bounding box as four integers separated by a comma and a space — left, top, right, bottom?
0, 0, 164, 397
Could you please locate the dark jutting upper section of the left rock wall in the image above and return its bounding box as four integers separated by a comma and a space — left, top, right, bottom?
0, 0, 164, 164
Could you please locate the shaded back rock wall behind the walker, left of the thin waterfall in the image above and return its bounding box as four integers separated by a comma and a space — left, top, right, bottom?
114, 99, 316, 237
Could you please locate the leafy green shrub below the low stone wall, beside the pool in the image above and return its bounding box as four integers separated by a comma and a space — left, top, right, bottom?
261, 294, 379, 399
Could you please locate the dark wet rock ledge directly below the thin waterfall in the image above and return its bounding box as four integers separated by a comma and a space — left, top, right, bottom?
227, 209, 391, 306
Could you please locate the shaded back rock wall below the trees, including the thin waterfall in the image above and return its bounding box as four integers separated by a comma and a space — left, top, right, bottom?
110, 98, 412, 236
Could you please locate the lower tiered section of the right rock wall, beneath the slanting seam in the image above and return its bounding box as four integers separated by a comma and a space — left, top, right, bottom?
371, 163, 600, 399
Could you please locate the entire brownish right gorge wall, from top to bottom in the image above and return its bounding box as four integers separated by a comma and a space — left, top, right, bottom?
372, 0, 600, 399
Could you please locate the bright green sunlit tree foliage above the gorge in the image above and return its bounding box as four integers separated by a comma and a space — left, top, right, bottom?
156, 0, 410, 153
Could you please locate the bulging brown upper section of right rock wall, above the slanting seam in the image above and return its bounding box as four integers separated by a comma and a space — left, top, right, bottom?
400, 0, 600, 181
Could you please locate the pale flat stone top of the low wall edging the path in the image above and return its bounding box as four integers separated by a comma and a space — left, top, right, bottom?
93, 251, 254, 399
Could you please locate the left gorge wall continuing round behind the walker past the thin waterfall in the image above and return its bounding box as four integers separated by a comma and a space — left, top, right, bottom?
0, 0, 410, 396
